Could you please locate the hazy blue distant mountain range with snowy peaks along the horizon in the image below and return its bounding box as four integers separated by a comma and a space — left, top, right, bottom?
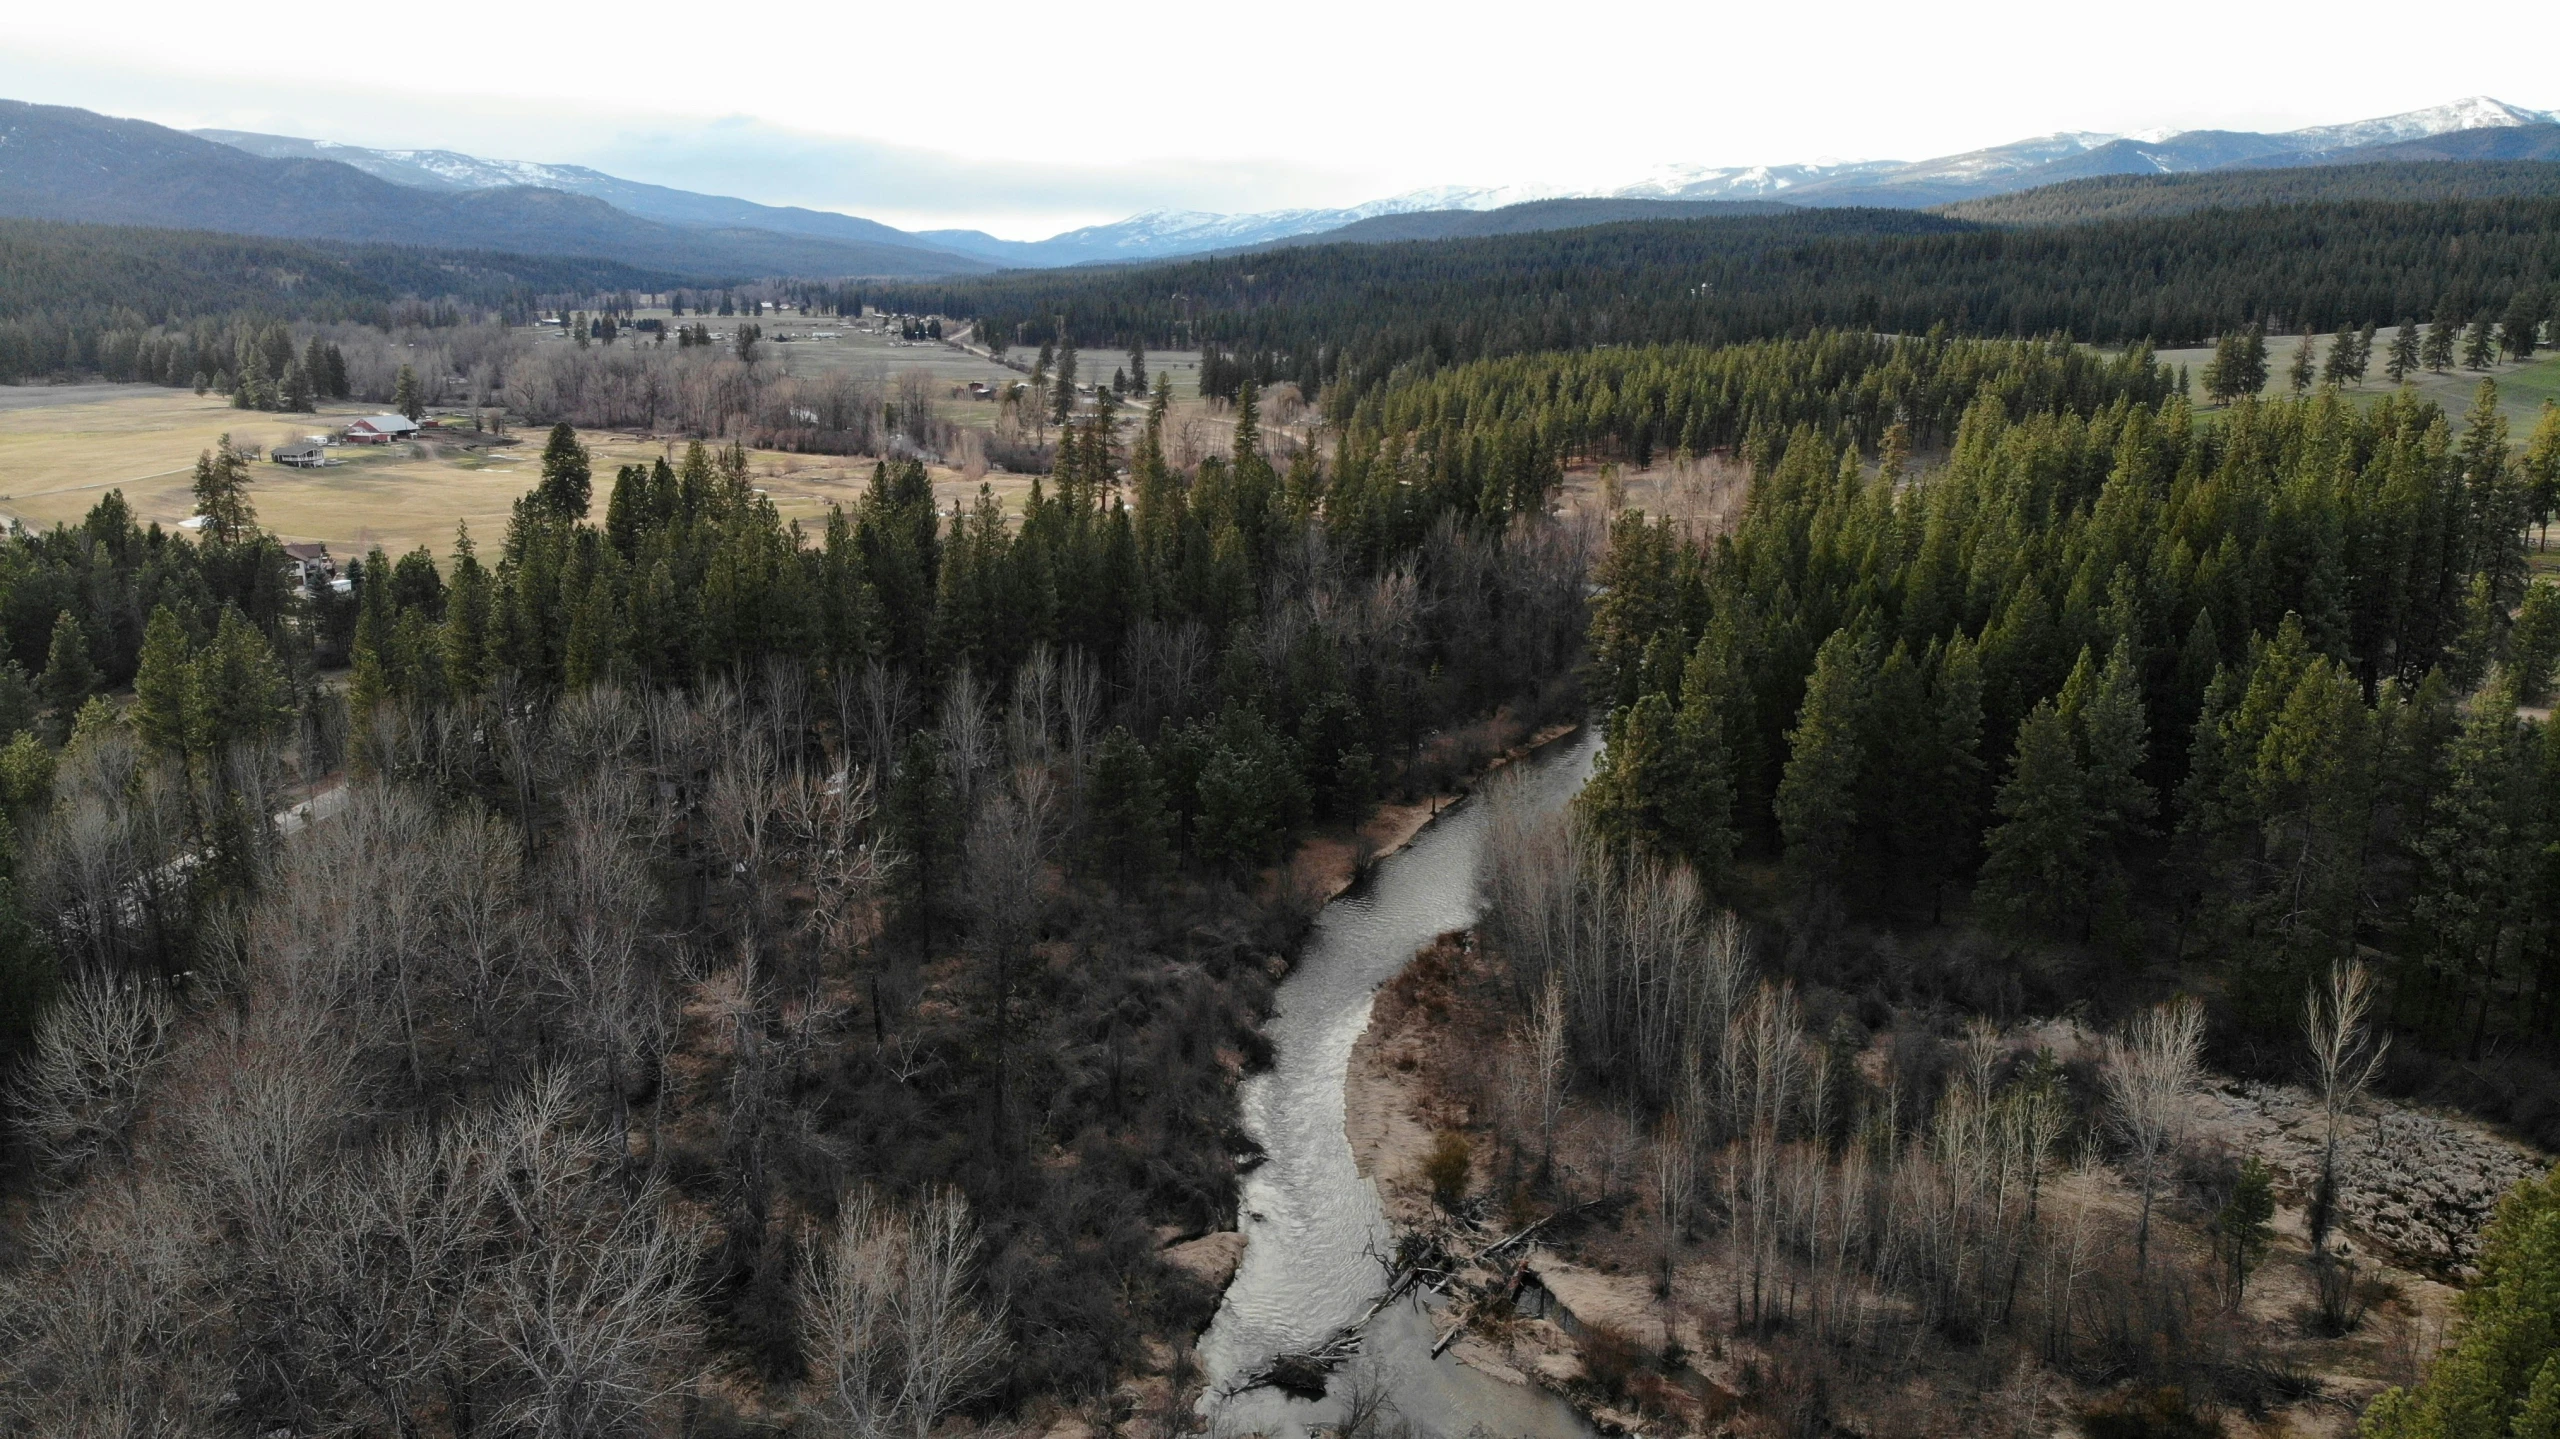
20, 95, 2560, 279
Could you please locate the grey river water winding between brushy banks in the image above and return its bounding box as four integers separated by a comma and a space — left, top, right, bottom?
1201, 725, 1600, 1439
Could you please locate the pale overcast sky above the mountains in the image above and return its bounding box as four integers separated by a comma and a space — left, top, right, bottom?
0, 0, 2560, 238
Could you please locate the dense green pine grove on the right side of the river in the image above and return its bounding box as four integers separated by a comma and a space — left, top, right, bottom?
1536, 335, 2560, 1052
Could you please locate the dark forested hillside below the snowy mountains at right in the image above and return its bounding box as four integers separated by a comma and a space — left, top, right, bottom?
883, 200, 2560, 415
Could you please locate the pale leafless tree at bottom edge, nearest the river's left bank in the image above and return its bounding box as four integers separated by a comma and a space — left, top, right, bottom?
799, 1188, 1006, 1439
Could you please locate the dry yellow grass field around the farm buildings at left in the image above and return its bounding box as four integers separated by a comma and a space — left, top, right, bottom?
0, 386, 1029, 556
